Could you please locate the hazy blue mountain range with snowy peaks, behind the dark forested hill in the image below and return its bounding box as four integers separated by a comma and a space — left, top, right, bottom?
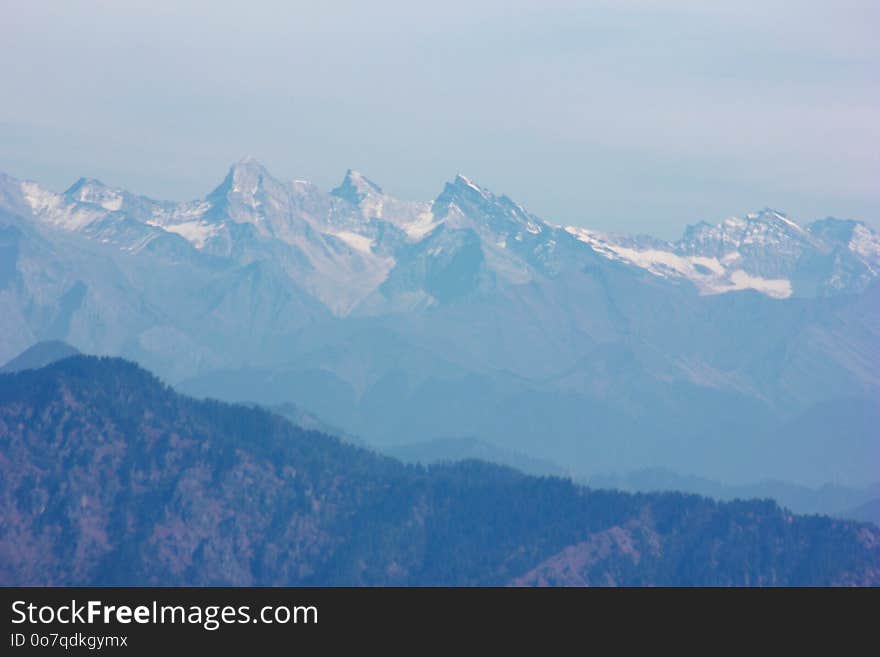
0, 158, 880, 485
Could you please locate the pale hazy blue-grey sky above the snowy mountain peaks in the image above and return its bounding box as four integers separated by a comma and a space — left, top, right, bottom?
0, 0, 880, 237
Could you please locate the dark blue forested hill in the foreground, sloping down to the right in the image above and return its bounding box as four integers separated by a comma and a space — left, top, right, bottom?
0, 356, 880, 585
